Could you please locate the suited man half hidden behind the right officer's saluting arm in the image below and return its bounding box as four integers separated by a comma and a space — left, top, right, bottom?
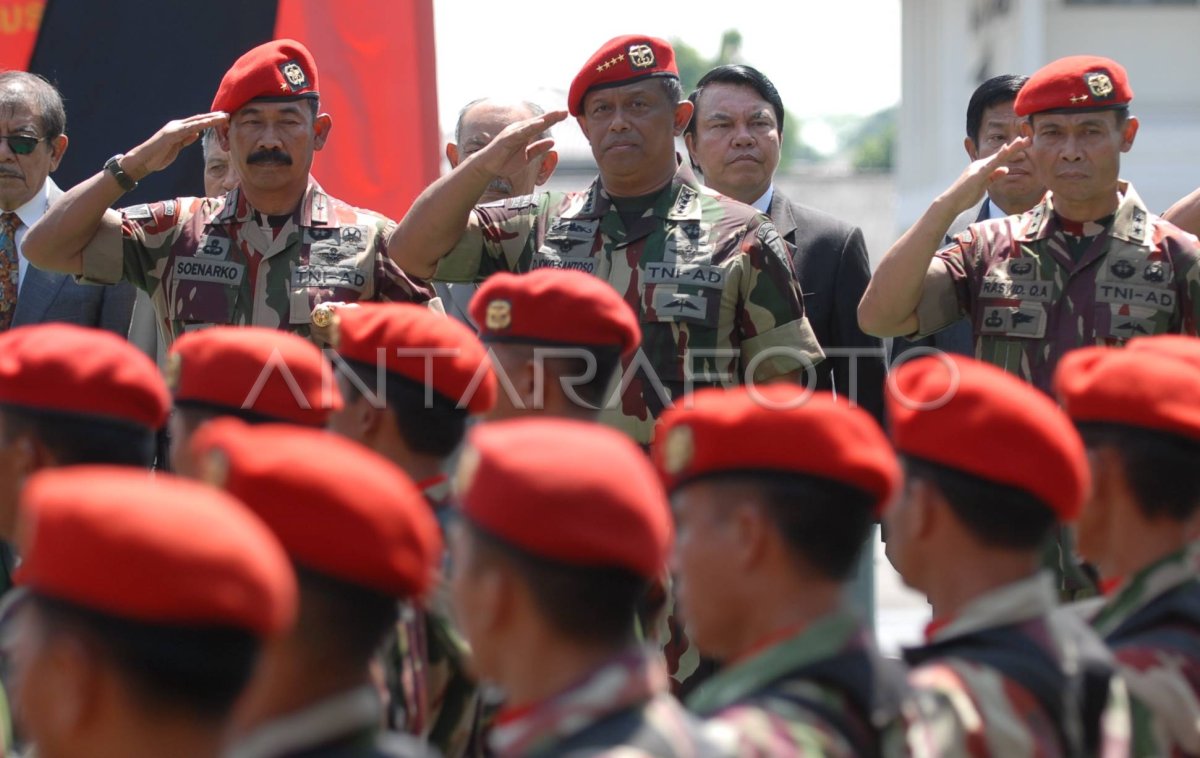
892, 73, 1046, 357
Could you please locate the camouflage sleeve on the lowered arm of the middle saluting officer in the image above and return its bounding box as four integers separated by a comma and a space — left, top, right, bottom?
739, 221, 824, 381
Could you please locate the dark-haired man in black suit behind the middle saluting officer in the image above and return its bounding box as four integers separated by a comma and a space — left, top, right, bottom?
684, 65, 886, 419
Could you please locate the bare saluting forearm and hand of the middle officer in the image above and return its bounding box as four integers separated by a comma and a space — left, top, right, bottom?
388, 110, 566, 279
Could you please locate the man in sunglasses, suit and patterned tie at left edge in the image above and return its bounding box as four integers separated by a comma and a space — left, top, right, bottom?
0, 71, 134, 337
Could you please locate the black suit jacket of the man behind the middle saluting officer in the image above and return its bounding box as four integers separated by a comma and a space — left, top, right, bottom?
767, 187, 887, 419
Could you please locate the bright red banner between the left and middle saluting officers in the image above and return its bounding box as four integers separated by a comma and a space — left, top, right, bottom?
275, 0, 442, 219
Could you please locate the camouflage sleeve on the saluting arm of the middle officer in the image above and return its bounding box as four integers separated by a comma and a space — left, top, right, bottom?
433, 193, 548, 282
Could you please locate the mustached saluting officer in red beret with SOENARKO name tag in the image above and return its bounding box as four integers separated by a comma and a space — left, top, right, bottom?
26, 40, 432, 345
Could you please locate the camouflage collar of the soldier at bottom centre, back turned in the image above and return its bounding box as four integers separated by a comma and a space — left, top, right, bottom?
488, 648, 668, 757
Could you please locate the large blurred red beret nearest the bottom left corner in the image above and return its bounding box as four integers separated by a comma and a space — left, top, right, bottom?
17, 465, 296, 637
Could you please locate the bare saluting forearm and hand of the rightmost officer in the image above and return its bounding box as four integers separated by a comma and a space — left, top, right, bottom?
858, 137, 1030, 337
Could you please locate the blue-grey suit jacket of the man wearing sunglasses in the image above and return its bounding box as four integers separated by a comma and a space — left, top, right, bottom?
12, 179, 137, 337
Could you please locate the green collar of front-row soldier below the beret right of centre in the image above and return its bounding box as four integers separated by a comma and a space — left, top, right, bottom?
688, 610, 865, 716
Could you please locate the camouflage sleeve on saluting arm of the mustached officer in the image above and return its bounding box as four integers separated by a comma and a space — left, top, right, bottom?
79, 198, 190, 294
